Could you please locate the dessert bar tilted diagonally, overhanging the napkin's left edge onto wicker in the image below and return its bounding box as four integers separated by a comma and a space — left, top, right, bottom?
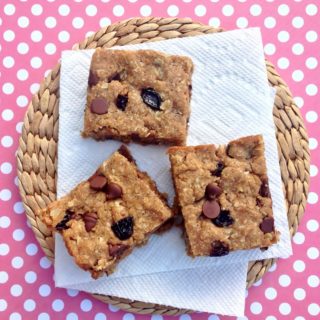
40, 146, 172, 278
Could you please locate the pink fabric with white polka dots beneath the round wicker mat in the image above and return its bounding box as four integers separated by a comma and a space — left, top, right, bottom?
0, 0, 320, 320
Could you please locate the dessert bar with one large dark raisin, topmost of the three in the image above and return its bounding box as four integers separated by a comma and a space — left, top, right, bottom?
83, 48, 193, 145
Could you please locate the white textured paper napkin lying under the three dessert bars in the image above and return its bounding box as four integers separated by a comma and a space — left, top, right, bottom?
55, 29, 291, 313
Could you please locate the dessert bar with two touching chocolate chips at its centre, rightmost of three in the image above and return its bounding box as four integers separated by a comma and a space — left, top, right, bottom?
168, 136, 279, 256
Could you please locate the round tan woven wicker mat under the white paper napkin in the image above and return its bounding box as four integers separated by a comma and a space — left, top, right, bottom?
17, 18, 310, 315
